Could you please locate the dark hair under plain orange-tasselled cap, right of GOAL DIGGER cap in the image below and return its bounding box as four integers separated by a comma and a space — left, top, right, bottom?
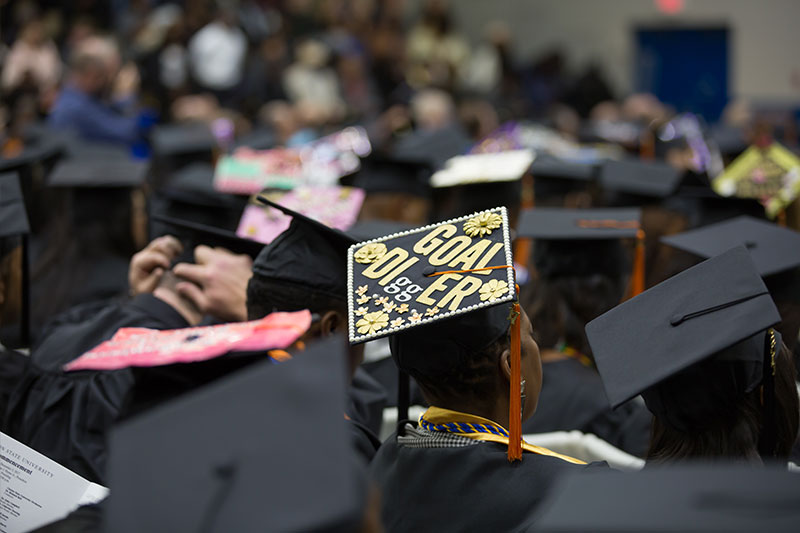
520, 274, 625, 357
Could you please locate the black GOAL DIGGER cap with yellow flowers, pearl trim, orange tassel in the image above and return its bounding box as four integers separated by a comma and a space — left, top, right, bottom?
347, 207, 522, 460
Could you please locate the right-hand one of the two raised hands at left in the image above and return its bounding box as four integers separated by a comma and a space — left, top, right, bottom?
172, 245, 253, 322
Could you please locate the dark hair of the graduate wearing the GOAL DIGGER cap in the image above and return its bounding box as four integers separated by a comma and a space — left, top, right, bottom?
408, 335, 511, 407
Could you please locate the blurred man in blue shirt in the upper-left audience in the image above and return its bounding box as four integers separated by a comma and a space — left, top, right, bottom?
48, 37, 143, 145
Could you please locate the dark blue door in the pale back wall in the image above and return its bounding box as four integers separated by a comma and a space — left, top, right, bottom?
634, 28, 729, 122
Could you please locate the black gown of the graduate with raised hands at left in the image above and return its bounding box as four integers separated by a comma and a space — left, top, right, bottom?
5, 294, 188, 484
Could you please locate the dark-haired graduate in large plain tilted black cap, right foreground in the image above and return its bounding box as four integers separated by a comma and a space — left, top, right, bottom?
586, 246, 800, 464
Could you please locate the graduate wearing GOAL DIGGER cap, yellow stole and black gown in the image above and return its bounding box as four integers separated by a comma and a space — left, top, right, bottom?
348, 208, 600, 531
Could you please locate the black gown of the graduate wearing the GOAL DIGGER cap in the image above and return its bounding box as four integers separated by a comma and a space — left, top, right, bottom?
370, 428, 594, 533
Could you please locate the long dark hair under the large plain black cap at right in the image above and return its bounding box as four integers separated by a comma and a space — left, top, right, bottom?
647, 345, 800, 463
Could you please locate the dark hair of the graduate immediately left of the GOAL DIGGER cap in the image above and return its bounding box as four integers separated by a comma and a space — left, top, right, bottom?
247, 274, 347, 320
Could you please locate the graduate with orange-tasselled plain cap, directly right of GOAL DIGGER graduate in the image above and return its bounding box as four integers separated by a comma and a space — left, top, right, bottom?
518, 208, 652, 457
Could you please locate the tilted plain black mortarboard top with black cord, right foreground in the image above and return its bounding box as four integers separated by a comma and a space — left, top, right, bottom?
586, 246, 780, 407
